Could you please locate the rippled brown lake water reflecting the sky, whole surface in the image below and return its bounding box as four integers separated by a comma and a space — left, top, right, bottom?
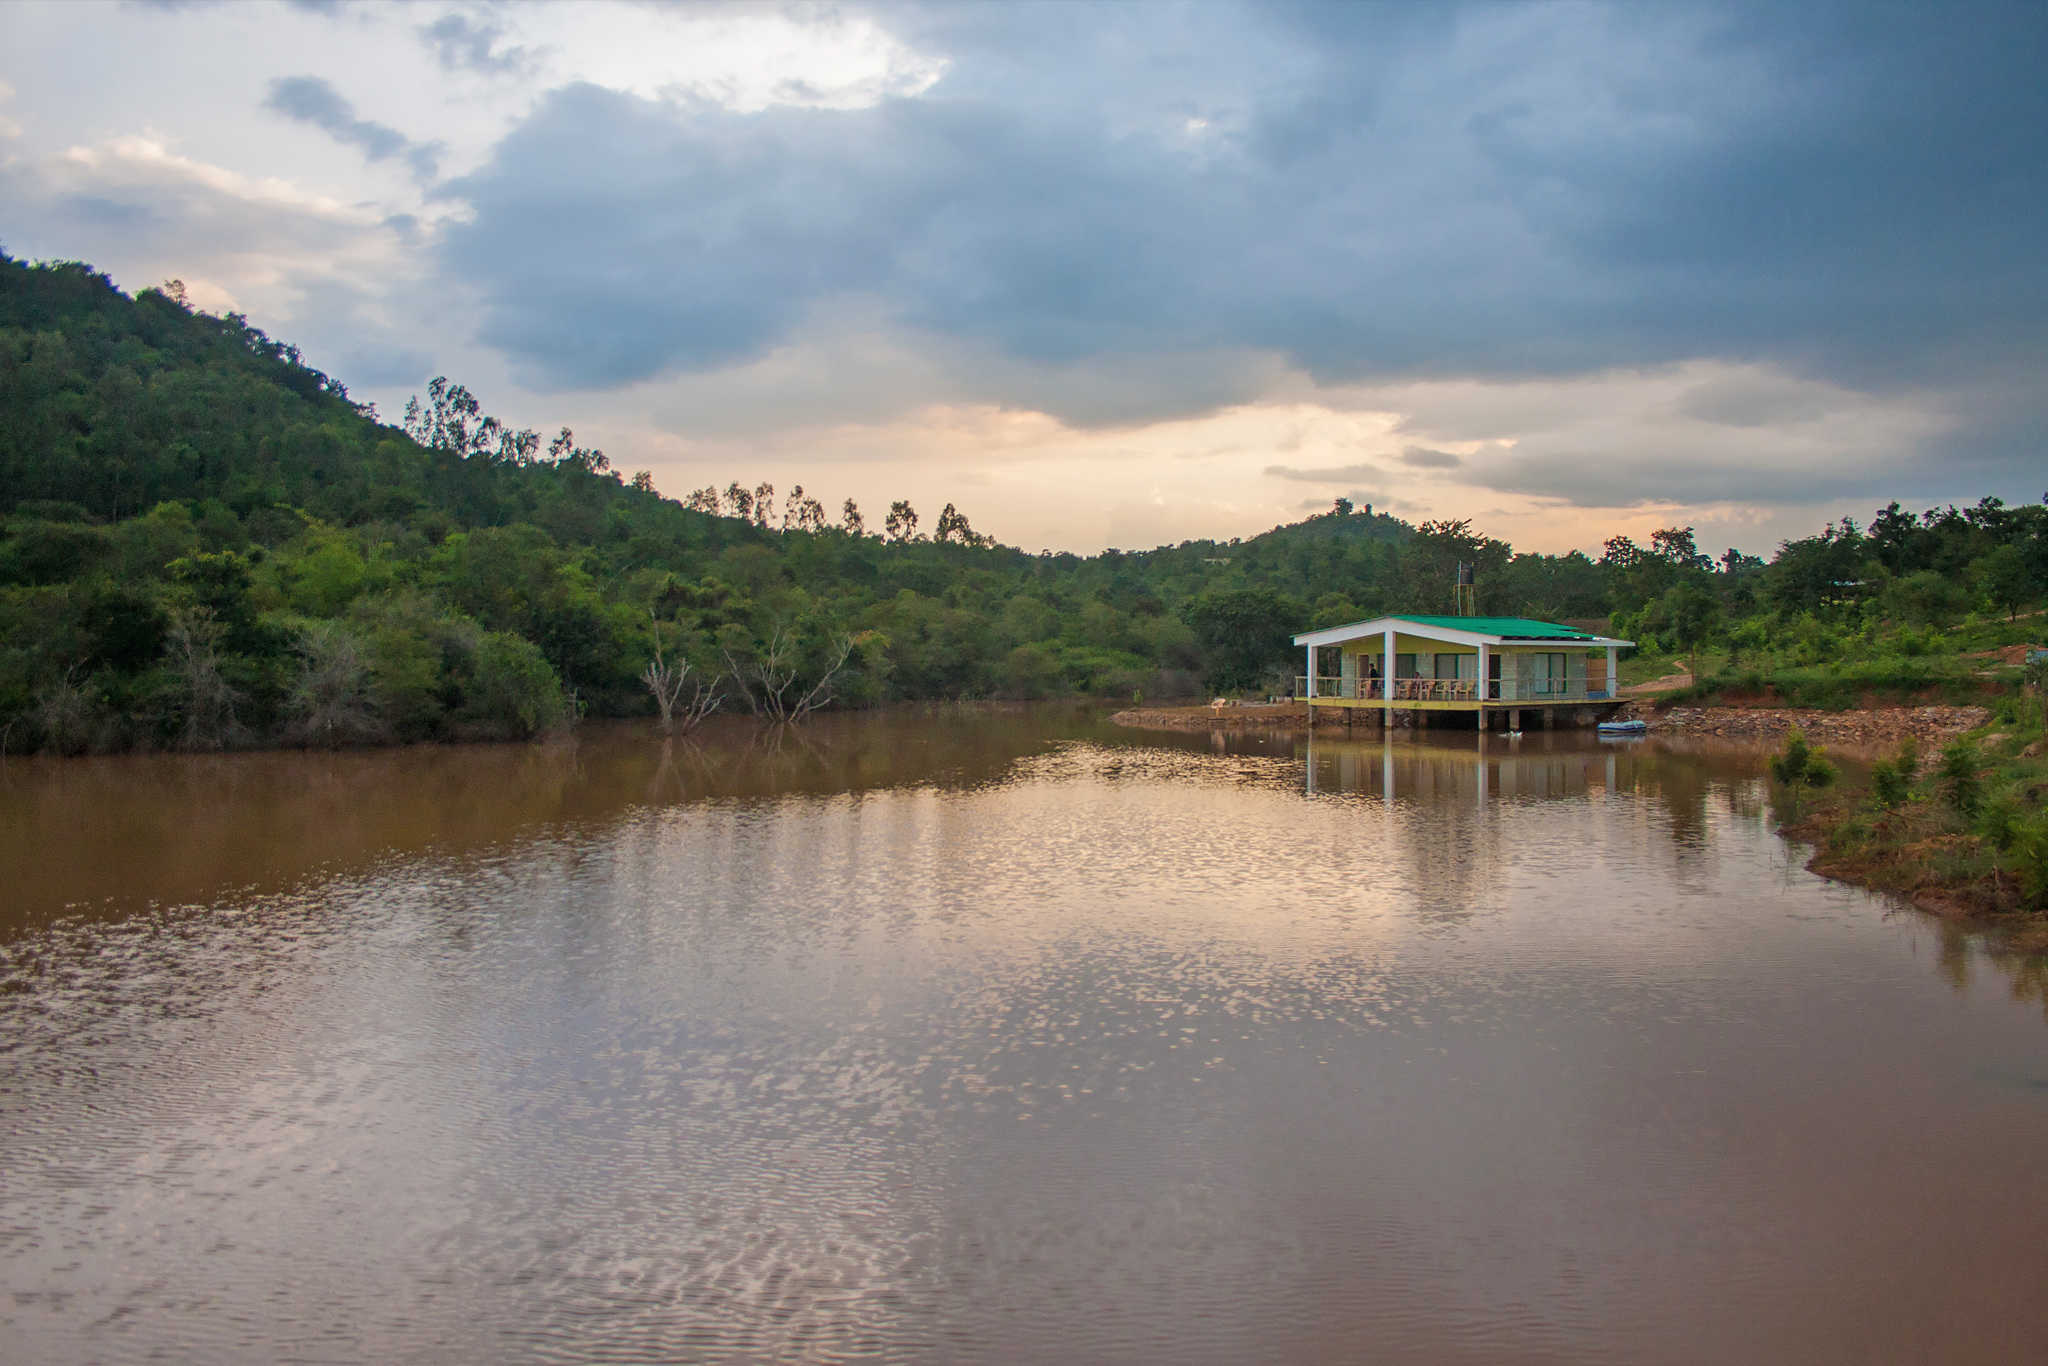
0, 709, 2048, 1364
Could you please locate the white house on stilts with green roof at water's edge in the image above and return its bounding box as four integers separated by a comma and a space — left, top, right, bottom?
1294, 616, 1634, 731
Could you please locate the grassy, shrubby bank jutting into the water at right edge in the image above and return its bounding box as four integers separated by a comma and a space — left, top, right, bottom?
1774, 664, 2048, 950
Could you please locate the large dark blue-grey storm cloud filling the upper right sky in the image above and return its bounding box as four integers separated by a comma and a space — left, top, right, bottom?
442, 4, 2048, 501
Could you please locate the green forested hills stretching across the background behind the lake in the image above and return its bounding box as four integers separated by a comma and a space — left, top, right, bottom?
0, 256, 2048, 752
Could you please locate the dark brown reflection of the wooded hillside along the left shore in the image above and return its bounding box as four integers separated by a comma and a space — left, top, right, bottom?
0, 707, 1087, 932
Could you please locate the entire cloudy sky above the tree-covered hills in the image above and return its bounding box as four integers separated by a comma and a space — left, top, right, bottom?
0, 0, 2048, 551
